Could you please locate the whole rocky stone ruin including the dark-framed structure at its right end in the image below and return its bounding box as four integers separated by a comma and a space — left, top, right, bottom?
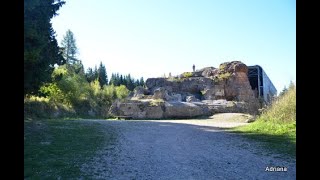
109, 61, 276, 119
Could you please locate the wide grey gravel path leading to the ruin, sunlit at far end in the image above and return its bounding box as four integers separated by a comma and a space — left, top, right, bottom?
82, 114, 296, 180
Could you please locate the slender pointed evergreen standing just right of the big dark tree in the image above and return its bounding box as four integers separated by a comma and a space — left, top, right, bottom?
61, 29, 79, 64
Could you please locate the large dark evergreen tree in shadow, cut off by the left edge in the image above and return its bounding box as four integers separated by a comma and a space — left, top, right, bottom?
24, 0, 65, 94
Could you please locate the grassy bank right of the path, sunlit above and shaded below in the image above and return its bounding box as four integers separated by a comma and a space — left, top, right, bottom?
232, 84, 296, 157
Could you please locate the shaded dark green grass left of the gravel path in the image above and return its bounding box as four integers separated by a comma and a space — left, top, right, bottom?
24, 119, 114, 179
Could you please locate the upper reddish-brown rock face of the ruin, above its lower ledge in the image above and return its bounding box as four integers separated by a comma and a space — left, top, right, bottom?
146, 61, 256, 104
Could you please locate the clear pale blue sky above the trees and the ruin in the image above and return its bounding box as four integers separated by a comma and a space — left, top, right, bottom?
52, 0, 296, 93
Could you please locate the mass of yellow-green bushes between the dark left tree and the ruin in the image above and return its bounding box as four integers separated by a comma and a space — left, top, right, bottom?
25, 64, 129, 118
